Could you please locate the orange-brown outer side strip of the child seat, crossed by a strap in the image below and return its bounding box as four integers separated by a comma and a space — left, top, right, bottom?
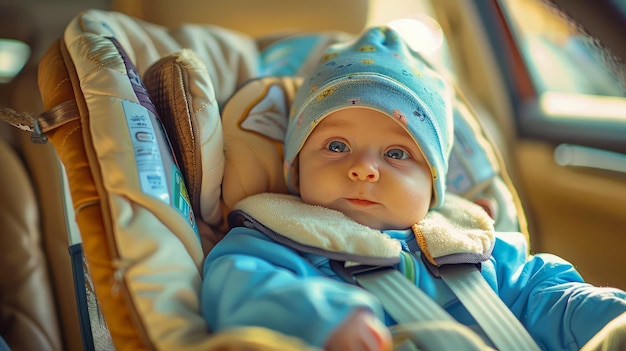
39, 40, 143, 350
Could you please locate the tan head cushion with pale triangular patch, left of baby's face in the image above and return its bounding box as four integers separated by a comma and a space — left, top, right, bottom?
222, 76, 301, 208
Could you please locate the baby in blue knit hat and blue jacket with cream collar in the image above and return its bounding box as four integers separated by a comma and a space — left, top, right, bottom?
201, 27, 626, 350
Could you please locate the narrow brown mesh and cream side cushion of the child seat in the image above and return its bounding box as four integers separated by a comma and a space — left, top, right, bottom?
143, 49, 224, 252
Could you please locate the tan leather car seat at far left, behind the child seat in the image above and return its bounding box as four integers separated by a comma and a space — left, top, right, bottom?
0, 125, 82, 350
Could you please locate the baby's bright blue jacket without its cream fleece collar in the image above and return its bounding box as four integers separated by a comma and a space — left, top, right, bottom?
201, 228, 626, 350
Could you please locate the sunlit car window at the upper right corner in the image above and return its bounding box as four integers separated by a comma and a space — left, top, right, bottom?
501, 0, 626, 121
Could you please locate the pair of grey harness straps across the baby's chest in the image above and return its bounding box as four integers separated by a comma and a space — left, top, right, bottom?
331, 261, 541, 351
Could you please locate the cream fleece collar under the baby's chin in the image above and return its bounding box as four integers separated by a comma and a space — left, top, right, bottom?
234, 193, 495, 265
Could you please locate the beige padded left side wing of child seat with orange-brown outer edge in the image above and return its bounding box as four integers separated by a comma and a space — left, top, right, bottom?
34, 9, 326, 350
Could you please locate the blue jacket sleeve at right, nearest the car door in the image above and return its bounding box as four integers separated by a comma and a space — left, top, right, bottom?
492, 232, 626, 350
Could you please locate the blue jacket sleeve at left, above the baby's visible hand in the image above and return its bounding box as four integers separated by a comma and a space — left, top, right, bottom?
200, 228, 383, 346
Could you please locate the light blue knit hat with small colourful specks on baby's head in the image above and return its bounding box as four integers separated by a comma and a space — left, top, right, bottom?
284, 27, 453, 208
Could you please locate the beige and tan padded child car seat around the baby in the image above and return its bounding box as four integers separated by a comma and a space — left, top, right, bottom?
5, 10, 525, 350
